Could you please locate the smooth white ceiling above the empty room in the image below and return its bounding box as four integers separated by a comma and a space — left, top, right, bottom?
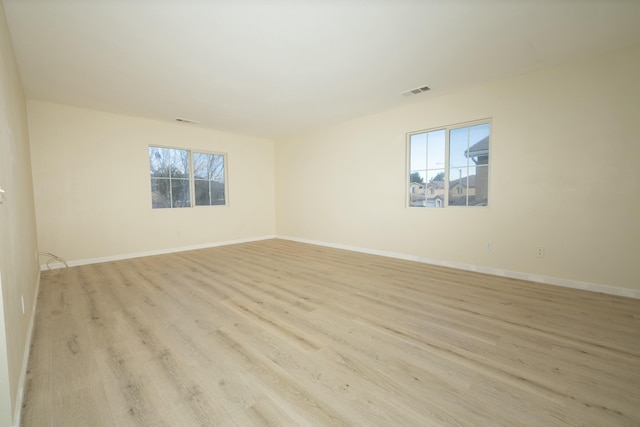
3, 0, 640, 138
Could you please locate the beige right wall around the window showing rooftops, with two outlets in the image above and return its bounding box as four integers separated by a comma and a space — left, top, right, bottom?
276, 47, 640, 290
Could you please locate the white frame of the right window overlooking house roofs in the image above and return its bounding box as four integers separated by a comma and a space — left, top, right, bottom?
405, 118, 493, 210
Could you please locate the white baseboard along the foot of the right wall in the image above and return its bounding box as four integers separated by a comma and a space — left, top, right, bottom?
276, 235, 640, 299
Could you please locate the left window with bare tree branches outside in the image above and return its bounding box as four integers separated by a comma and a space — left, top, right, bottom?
149, 146, 226, 209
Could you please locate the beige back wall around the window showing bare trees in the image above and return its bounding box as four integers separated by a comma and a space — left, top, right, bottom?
28, 100, 275, 262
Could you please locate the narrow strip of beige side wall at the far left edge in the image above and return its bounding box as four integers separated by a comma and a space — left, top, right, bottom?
0, 4, 38, 427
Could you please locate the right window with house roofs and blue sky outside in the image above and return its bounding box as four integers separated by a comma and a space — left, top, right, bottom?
408, 121, 490, 208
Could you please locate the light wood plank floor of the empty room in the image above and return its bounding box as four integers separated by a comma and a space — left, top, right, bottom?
22, 240, 640, 427
